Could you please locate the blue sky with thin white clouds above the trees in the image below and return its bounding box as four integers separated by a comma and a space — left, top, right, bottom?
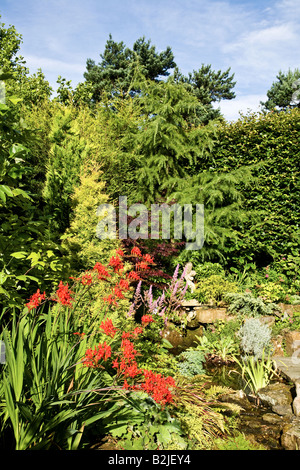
0, 0, 300, 120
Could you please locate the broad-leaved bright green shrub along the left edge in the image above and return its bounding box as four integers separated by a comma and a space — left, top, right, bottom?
0, 81, 64, 307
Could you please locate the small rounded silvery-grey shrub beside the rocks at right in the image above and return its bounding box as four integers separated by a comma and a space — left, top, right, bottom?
238, 318, 271, 359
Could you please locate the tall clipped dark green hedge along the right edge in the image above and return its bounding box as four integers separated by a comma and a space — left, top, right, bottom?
199, 109, 300, 266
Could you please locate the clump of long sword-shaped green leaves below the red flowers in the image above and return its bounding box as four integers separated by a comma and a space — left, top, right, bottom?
0, 309, 114, 450
